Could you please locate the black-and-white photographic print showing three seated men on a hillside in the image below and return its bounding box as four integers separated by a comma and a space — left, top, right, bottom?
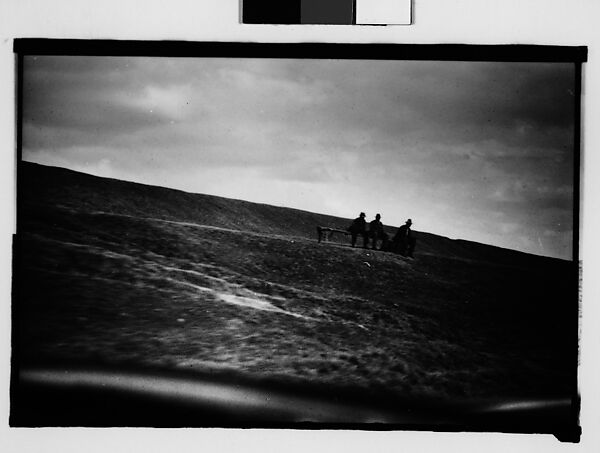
11, 42, 582, 440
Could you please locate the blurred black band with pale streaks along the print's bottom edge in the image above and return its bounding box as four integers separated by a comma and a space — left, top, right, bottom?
11, 366, 579, 442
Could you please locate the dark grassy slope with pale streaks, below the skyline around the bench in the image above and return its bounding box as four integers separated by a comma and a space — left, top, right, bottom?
16, 164, 573, 397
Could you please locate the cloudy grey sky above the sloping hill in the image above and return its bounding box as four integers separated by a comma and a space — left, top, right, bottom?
23, 57, 574, 259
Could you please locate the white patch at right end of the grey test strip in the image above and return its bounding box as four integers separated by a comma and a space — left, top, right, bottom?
356, 0, 411, 25
